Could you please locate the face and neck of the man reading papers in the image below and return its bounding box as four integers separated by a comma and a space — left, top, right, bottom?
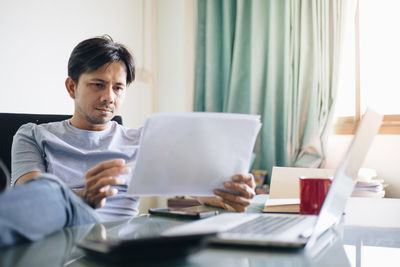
66, 61, 127, 130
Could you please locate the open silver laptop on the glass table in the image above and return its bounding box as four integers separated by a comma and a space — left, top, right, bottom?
162, 109, 383, 248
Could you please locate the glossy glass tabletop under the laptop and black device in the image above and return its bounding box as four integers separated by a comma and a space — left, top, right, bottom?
0, 196, 400, 267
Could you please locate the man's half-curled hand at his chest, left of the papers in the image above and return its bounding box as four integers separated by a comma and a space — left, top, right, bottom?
75, 159, 131, 208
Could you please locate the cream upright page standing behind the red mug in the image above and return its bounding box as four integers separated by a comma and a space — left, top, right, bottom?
267, 166, 335, 200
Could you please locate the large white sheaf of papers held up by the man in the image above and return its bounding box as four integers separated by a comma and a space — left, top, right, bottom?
128, 112, 261, 196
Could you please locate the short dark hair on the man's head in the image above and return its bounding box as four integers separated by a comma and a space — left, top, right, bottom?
68, 35, 135, 85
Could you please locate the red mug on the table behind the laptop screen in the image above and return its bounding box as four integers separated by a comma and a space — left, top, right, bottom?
300, 177, 332, 215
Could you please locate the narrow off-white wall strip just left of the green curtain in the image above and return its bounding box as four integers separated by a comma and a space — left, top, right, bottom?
155, 0, 195, 206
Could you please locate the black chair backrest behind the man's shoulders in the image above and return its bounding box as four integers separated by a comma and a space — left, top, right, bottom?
0, 113, 122, 175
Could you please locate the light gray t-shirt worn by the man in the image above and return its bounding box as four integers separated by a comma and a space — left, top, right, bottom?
11, 120, 140, 221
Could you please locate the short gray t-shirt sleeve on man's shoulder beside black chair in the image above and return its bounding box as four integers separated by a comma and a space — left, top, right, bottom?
11, 123, 46, 185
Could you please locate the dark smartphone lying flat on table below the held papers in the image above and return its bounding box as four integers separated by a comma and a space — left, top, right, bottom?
149, 206, 218, 219
